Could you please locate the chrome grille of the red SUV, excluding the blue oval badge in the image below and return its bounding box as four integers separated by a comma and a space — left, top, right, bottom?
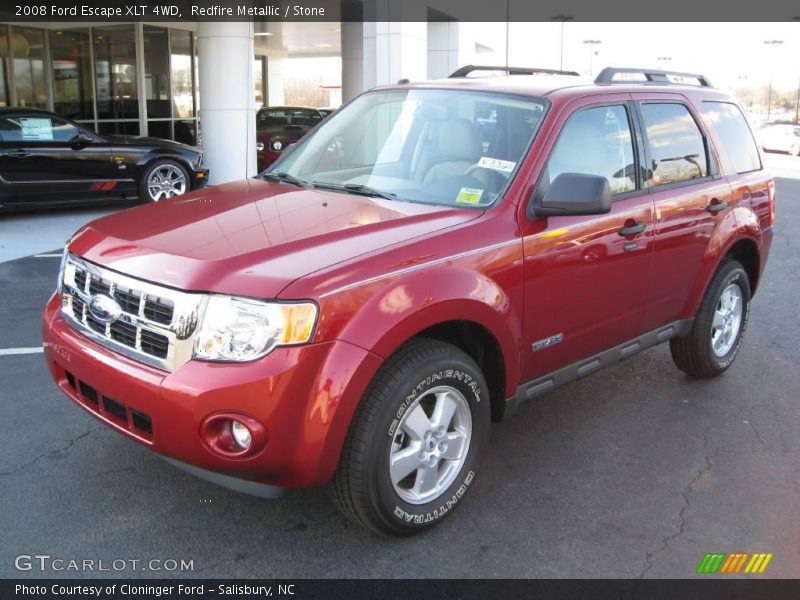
61, 254, 204, 371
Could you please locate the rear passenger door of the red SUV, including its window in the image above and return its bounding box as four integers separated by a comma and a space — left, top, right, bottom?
633, 93, 732, 331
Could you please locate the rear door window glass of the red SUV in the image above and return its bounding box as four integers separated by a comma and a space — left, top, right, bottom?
641, 102, 708, 186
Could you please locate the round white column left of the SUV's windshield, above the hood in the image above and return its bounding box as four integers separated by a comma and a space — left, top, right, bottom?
197, 21, 256, 183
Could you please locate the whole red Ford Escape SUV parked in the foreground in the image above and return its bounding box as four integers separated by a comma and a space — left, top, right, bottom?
44, 69, 774, 535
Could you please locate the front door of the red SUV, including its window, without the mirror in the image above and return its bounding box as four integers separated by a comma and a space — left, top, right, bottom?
520, 94, 653, 380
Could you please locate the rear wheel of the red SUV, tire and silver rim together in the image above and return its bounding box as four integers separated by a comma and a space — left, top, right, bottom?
670, 260, 750, 377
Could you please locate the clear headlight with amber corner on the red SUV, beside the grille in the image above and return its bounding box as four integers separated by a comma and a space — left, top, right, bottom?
194, 295, 317, 362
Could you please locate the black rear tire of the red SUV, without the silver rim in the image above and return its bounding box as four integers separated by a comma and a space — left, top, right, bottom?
669, 260, 750, 377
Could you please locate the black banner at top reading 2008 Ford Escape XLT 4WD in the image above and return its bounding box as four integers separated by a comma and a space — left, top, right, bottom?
0, 0, 800, 22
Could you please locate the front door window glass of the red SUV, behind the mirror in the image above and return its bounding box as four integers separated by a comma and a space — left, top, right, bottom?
543, 105, 636, 194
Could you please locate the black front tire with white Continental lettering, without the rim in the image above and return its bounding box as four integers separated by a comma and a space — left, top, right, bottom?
332, 338, 491, 536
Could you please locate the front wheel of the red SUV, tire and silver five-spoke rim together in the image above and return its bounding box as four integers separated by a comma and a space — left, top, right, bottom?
332, 339, 490, 536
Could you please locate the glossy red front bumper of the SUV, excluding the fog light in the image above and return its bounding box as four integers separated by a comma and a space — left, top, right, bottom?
43, 294, 381, 495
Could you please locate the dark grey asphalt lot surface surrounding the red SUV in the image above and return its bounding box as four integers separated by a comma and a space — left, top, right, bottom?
0, 156, 800, 578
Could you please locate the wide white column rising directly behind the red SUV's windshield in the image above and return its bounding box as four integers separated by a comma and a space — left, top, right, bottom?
341, 21, 428, 102
